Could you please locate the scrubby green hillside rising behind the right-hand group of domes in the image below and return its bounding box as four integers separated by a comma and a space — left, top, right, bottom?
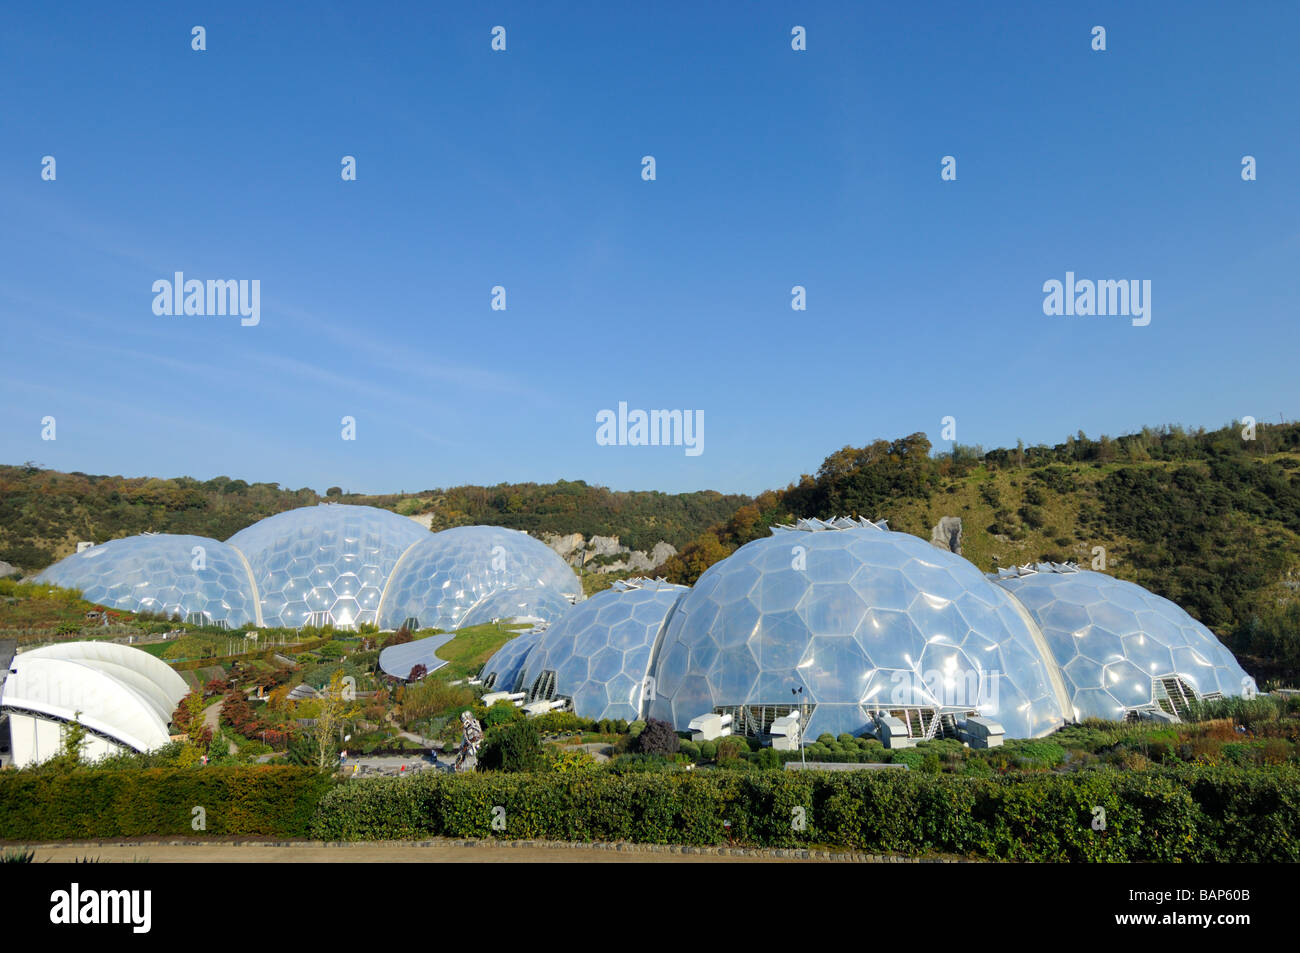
664, 424, 1300, 679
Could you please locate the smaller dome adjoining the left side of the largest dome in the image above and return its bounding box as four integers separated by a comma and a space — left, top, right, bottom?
521, 579, 688, 722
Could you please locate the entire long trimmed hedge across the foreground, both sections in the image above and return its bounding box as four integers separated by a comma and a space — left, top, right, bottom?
0, 766, 1300, 862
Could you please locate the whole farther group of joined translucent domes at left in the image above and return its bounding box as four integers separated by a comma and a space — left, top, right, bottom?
36, 503, 582, 629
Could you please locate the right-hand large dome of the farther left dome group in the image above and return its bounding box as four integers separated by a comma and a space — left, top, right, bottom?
381, 527, 582, 629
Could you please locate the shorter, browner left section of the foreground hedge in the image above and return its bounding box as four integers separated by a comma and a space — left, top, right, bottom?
0, 764, 333, 841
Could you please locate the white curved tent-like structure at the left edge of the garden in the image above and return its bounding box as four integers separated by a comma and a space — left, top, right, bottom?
0, 642, 189, 767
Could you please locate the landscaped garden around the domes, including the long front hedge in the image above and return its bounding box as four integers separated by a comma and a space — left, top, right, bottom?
0, 587, 1300, 861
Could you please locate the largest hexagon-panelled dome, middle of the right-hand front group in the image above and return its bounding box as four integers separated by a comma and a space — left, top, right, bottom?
649, 519, 1066, 737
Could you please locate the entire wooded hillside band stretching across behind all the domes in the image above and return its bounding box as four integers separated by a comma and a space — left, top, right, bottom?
0, 424, 1300, 677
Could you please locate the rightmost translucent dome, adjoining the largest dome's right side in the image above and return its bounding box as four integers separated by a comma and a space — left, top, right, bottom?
996, 563, 1256, 720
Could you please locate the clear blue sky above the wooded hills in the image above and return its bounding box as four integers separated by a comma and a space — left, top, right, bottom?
0, 3, 1300, 493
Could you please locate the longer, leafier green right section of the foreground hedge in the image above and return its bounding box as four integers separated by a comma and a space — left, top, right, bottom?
311, 767, 1300, 862
